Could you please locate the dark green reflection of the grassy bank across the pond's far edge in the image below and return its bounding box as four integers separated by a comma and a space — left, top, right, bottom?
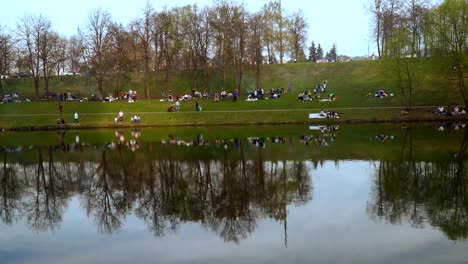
0, 124, 465, 163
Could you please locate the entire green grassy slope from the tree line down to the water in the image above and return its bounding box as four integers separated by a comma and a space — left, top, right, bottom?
0, 61, 461, 128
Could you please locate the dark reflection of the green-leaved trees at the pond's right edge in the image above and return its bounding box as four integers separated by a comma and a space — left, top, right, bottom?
368, 129, 468, 240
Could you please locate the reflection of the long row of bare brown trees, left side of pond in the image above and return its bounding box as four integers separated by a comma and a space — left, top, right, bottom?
0, 135, 312, 243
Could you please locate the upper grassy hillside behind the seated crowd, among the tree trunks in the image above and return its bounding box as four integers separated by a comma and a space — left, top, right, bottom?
3, 61, 462, 107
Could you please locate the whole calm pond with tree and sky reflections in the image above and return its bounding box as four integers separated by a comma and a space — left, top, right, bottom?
0, 124, 468, 264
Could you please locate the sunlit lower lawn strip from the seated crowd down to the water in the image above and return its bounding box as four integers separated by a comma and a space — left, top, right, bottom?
0, 94, 467, 130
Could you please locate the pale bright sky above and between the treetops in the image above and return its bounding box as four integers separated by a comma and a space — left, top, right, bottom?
0, 0, 376, 56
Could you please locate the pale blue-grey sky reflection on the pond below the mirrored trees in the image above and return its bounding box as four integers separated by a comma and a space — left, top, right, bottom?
0, 126, 468, 264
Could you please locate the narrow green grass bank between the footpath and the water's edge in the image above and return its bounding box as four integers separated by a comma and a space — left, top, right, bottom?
0, 103, 468, 131
